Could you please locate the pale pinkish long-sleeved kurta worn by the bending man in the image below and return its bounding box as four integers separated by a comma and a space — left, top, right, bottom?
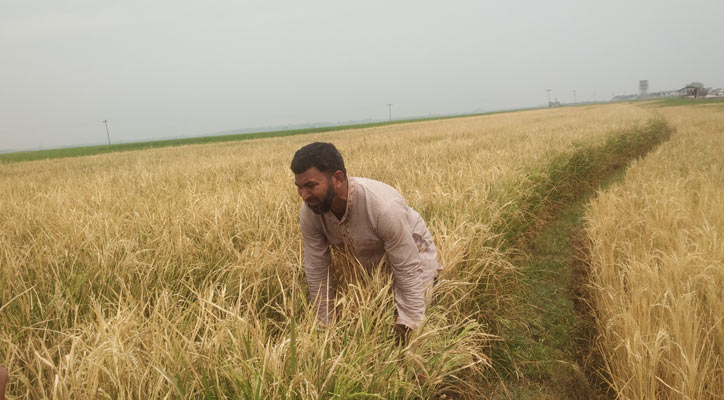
300, 177, 442, 328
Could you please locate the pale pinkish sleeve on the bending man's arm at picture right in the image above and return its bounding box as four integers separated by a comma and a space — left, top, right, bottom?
377, 201, 425, 328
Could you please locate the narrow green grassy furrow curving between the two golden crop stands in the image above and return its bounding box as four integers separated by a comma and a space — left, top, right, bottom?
493, 120, 671, 399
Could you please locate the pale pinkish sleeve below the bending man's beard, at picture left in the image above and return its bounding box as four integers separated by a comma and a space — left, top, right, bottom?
299, 206, 336, 323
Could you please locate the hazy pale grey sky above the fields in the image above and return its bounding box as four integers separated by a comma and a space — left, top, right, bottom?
0, 0, 724, 150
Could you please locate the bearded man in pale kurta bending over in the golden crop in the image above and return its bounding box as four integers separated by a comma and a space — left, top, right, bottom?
291, 142, 442, 333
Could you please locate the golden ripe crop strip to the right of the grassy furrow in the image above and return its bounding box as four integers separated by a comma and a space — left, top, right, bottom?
587, 104, 724, 399
